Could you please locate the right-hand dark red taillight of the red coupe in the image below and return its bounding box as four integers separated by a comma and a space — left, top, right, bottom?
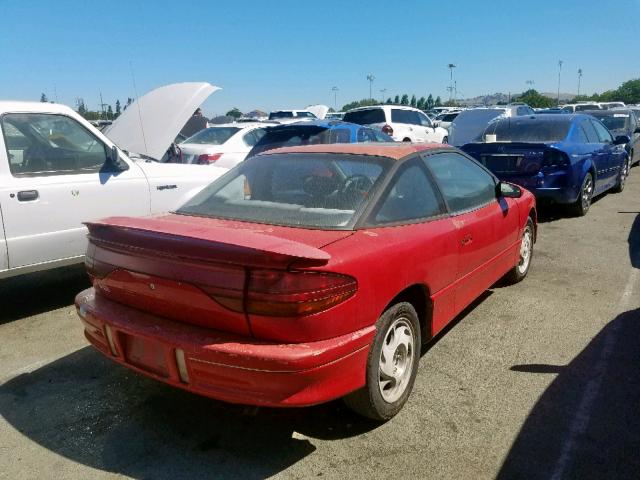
212, 270, 358, 317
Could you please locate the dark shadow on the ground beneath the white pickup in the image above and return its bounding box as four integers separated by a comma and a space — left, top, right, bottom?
0, 264, 91, 325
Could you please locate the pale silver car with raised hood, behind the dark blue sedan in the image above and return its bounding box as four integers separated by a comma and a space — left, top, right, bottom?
449, 104, 535, 147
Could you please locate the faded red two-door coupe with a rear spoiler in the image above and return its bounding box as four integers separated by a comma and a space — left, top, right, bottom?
76, 144, 536, 420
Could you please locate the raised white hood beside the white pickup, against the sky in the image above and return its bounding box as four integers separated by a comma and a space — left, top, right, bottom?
103, 82, 220, 160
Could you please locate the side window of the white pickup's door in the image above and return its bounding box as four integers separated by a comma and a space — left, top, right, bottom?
1, 113, 107, 177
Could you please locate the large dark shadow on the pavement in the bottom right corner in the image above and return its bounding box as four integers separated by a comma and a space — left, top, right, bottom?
497, 309, 640, 480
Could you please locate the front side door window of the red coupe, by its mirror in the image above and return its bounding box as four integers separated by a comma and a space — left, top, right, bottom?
425, 152, 496, 213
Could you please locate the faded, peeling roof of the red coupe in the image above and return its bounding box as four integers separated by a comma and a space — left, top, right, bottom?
259, 142, 453, 160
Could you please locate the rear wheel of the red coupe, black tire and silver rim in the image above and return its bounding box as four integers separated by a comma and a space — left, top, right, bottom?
344, 302, 421, 421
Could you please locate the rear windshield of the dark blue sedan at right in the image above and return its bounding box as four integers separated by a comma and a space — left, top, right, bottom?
483, 117, 571, 143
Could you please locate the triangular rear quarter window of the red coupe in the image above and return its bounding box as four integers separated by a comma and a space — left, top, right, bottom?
373, 158, 444, 225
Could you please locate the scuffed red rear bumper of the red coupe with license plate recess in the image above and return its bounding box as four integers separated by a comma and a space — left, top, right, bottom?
76, 288, 375, 407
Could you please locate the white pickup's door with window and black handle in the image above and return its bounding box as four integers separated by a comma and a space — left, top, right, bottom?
0, 113, 150, 269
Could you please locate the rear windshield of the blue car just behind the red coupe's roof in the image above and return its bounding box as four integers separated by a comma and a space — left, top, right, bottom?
249, 125, 351, 156
